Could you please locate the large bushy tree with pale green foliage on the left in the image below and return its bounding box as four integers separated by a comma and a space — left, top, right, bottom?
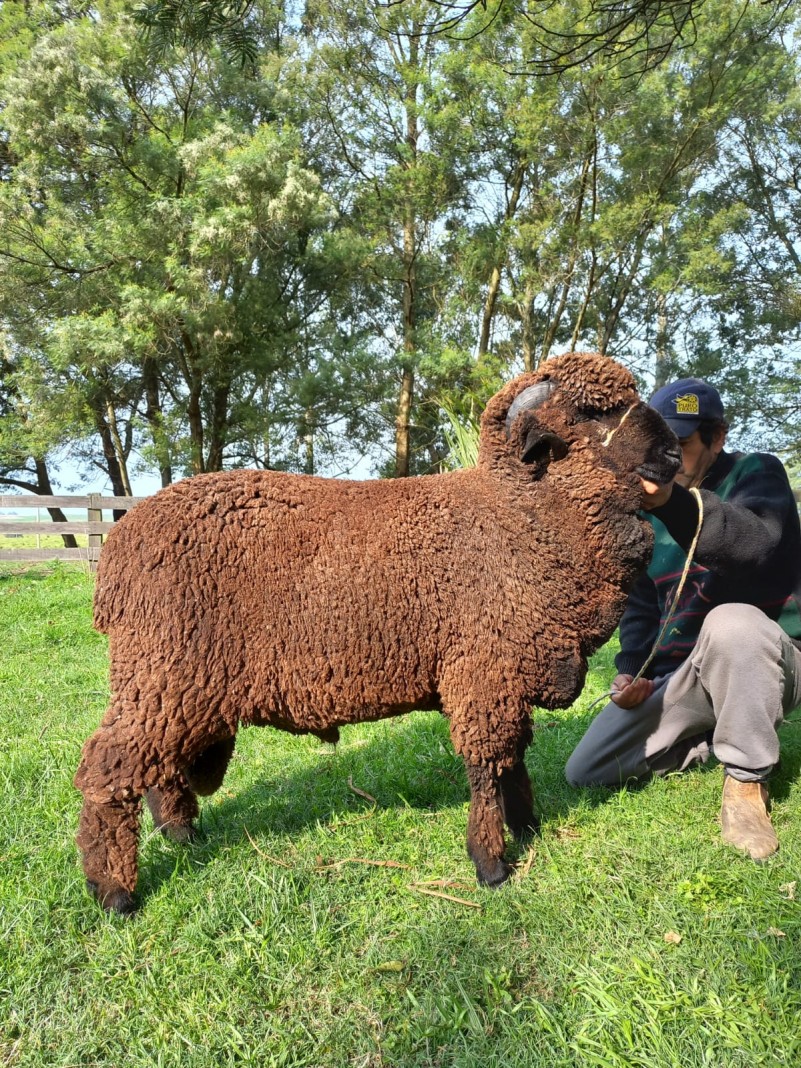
0, 4, 386, 484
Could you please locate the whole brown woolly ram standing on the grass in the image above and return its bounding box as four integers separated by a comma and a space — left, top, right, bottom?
75, 354, 676, 911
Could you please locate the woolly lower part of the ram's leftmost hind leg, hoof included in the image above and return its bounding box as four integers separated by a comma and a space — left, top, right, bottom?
77, 798, 141, 913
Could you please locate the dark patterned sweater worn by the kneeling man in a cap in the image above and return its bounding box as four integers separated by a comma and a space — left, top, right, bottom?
615, 452, 801, 678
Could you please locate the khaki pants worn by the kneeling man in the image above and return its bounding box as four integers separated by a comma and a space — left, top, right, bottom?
565, 604, 801, 786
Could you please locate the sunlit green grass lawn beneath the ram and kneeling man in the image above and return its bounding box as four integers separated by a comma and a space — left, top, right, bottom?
0, 565, 801, 1068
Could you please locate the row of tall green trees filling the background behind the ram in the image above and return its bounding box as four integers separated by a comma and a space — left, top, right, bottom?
0, 0, 801, 486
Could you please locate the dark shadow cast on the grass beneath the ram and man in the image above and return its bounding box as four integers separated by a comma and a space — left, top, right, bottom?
133, 712, 801, 900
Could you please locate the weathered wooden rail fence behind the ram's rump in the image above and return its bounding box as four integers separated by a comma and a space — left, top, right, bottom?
0, 493, 144, 570
